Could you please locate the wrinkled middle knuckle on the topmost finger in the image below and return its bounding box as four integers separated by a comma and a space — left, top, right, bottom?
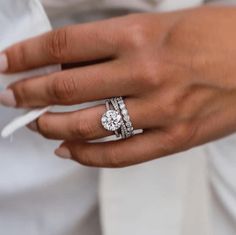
44, 28, 69, 61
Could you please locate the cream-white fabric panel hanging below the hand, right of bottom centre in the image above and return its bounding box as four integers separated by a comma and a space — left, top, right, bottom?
101, 148, 209, 235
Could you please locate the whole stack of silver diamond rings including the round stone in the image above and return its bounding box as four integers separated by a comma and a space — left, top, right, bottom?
101, 97, 134, 139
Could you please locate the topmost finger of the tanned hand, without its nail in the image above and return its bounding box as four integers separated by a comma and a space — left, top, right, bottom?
3, 21, 116, 73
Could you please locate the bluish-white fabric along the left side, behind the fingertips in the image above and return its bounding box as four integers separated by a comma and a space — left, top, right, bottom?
0, 0, 99, 235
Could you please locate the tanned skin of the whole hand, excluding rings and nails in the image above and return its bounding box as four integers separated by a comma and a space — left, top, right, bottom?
0, 7, 236, 167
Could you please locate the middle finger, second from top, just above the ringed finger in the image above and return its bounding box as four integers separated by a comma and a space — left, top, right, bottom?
6, 61, 138, 108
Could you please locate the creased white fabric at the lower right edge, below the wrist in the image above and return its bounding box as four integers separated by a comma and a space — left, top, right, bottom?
207, 135, 236, 235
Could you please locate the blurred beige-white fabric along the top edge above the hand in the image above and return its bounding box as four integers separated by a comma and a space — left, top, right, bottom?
41, 0, 204, 24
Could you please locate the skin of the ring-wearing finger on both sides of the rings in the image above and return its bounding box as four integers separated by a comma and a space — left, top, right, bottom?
30, 98, 160, 140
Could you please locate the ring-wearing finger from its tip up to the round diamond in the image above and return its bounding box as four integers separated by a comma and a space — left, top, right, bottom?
33, 105, 109, 140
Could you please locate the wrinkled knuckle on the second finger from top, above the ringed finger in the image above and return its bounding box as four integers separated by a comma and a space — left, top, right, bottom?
49, 76, 78, 103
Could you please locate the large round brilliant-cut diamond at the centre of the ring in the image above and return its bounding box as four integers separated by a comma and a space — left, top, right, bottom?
101, 110, 122, 131
